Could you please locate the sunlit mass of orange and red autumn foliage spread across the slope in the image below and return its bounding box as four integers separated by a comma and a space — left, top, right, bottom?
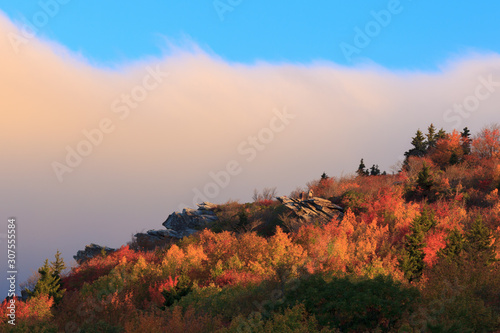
16, 124, 500, 332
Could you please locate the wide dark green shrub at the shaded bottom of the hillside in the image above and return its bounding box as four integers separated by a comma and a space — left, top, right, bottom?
284, 275, 419, 332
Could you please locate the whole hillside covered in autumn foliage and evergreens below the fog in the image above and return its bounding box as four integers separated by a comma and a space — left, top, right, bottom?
0, 125, 500, 332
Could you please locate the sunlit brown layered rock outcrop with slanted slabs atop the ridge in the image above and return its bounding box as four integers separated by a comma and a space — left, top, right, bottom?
277, 196, 344, 221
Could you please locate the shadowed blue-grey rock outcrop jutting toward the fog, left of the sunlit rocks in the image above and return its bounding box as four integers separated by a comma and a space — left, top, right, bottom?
135, 202, 218, 248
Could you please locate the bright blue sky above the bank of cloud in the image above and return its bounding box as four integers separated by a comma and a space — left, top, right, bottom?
0, 0, 500, 70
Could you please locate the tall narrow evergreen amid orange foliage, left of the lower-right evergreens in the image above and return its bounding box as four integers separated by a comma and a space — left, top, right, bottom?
399, 209, 436, 282
